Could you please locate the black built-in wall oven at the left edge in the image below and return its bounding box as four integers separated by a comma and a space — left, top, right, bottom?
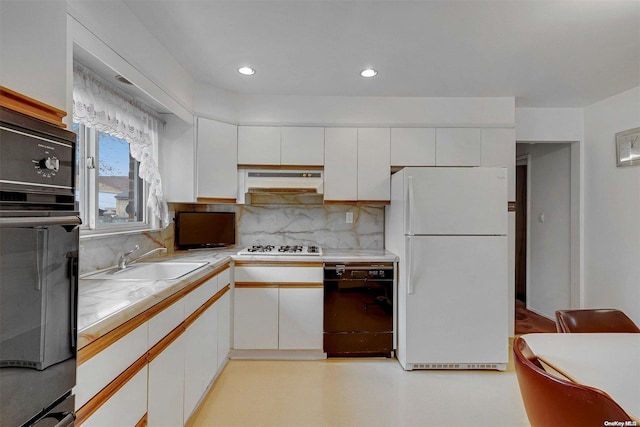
0, 108, 80, 427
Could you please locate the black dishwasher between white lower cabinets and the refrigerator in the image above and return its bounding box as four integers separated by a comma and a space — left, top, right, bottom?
323, 262, 394, 357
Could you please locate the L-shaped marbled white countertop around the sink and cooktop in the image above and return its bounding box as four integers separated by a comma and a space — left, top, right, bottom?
78, 249, 398, 348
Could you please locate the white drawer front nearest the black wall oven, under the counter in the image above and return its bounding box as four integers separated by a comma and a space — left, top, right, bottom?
75, 322, 148, 412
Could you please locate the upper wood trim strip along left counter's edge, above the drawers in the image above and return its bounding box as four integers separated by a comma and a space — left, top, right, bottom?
77, 263, 230, 365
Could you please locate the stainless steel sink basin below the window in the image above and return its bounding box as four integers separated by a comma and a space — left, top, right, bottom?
83, 261, 209, 280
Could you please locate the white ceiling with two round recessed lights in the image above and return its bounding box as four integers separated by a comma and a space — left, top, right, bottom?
124, 0, 640, 107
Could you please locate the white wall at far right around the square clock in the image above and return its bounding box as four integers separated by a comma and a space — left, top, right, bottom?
584, 87, 640, 324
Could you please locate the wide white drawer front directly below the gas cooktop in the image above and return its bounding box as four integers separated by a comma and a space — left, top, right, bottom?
234, 265, 322, 283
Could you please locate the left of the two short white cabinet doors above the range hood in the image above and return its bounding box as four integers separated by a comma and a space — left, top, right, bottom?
238, 126, 280, 165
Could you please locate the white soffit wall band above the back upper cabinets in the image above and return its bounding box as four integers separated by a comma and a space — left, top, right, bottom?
194, 85, 515, 127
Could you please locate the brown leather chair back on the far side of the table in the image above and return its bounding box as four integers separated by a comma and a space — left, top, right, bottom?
556, 308, 640, 332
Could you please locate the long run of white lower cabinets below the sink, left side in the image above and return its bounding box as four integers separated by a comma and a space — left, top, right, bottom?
75, 266, 232, 427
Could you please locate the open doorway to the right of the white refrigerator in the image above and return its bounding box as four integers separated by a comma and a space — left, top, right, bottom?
513, 141, 581, 319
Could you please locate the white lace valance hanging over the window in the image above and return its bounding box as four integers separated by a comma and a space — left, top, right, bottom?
73, 62, 169, 226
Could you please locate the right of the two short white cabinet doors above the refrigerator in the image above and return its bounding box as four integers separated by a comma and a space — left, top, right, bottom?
436, 128, 481, 166
